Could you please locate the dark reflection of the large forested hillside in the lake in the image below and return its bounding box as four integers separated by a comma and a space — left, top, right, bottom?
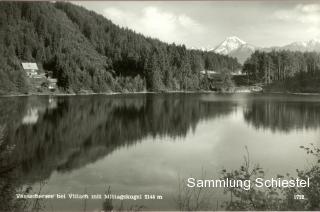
0, 94, 234, 182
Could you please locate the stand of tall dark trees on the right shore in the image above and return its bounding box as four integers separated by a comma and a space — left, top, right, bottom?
243, 51, 320, 92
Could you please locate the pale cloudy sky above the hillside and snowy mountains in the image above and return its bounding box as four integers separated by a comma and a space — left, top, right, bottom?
74, 0, 320, 48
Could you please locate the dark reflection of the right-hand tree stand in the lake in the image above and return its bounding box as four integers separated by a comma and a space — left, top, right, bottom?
244, 100, 320, 132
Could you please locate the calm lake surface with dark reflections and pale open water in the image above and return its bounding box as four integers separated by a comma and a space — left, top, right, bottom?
0, 94, 320, 211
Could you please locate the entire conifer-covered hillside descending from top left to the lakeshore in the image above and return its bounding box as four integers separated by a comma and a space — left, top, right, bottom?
0, 2, 240, 93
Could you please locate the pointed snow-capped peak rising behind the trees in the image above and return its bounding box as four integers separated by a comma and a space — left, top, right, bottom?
213, 36, 256, 63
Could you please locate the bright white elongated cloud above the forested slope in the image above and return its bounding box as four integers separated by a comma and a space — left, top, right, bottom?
103, 6, 205, 44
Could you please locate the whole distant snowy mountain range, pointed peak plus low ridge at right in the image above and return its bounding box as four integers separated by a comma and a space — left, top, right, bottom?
211, 36, 320, 64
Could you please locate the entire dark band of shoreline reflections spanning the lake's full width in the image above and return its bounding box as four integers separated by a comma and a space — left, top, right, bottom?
0, 94, 320, 209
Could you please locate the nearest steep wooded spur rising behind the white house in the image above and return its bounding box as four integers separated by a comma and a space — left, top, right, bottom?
0, 2, 111, 93
